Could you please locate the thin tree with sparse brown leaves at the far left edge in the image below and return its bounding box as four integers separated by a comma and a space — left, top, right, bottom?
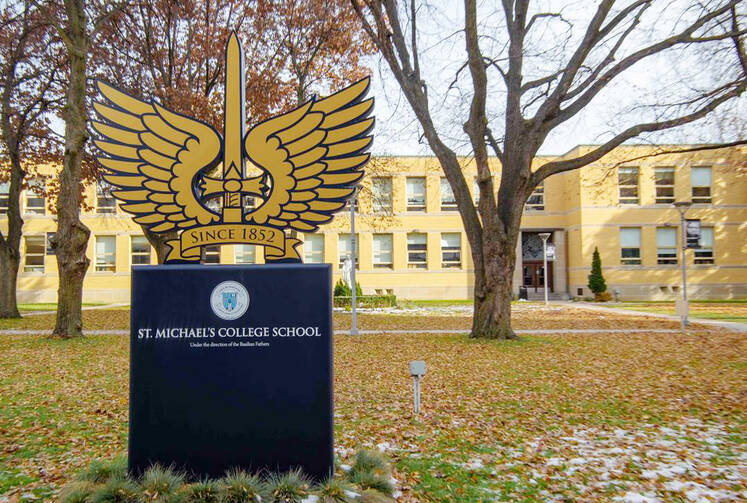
0, 0, 60, 318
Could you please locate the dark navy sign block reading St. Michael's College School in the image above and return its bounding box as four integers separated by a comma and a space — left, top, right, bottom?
129, 264, 333, 479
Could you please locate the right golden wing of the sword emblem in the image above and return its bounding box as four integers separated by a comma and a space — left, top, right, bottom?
244, 78, 374, 232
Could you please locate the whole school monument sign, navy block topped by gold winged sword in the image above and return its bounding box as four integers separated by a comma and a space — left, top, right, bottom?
92, 34, 374, 478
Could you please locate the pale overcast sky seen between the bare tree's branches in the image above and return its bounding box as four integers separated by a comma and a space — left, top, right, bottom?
360, 0, 747, 155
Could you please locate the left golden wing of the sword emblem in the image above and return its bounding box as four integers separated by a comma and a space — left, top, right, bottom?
92, 81, 222, 232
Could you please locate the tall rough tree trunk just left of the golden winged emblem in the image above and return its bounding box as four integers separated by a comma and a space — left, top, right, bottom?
52, 0, 91, 338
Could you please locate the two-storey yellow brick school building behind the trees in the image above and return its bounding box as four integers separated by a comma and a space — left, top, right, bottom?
0, 146, 747, 302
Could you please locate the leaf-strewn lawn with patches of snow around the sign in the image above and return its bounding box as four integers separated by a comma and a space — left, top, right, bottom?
0, 305, 747, 501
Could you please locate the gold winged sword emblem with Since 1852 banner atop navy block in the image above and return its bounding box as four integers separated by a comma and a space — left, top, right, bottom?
92, 33, 374, 263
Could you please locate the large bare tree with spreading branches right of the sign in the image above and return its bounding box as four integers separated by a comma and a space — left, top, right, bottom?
352, 0, 747, 338
